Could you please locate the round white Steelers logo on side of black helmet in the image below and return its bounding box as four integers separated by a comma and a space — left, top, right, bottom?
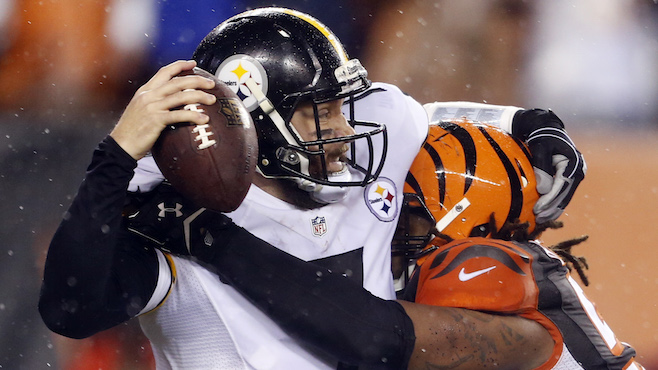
215, 54, 267, 112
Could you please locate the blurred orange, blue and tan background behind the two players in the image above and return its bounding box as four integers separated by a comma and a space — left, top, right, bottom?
0, 0, 658, 369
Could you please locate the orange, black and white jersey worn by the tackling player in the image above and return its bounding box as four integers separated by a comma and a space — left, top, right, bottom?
410, 238, 642, 370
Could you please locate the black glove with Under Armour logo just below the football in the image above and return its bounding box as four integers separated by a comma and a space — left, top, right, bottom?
123, 182, 233, 255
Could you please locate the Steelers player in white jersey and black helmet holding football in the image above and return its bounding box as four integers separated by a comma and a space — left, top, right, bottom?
39, 8, 585, 369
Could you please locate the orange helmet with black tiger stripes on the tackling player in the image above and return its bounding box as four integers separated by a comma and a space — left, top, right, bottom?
404, 121, 539, 250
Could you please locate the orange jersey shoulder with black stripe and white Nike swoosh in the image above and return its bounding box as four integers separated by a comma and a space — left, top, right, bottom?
416, 238, 539, 313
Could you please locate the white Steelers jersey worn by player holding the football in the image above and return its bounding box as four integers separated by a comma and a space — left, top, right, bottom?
140, 84, 428, 369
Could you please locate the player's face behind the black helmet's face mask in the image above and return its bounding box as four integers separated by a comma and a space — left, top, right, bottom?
290, 99, 355, 176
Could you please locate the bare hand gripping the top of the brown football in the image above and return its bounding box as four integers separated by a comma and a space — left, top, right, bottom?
110, 61, 216, 159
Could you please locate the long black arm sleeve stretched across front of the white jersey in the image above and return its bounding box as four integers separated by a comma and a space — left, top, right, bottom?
193, 224, 415, 369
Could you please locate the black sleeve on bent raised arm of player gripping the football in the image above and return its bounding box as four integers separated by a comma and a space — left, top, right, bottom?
39, 136, 158, 338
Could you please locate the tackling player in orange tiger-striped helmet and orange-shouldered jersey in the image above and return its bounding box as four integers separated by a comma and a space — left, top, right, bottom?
163, 122, 642, 369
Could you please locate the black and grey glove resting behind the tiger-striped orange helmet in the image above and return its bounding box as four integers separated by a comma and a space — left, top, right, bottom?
512, 109, 587, 223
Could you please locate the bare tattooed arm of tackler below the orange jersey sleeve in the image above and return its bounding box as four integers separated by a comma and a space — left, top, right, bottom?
401, 302, 554, 369
